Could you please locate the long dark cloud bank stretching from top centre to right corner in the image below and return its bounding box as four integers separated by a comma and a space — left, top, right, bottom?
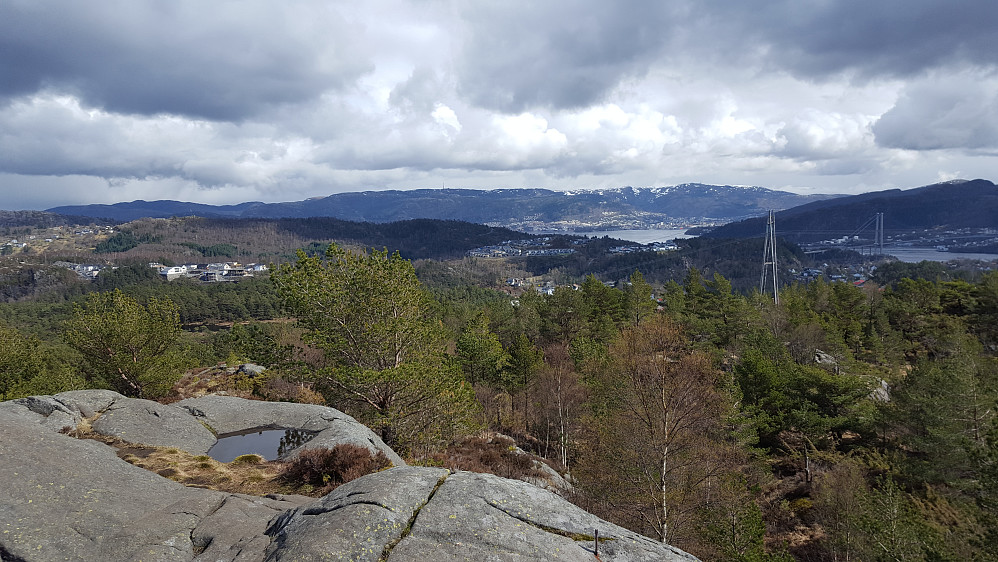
458, 0, 998, 112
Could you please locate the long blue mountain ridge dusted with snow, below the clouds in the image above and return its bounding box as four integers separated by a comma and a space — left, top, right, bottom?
48, 183, 836, 229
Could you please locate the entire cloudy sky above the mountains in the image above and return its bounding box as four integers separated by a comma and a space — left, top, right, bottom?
0, 0, 998, 209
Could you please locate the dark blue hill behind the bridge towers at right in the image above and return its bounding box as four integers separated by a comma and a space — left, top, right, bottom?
705, 179, 998, 242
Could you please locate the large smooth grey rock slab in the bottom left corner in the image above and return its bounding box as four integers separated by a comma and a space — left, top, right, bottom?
0, 402, 311, 561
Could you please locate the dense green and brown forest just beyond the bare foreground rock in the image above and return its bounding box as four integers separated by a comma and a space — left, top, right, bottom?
0, 221, 998, 560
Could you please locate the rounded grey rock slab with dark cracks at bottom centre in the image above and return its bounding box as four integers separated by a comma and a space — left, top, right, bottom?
267, 468, 695, 562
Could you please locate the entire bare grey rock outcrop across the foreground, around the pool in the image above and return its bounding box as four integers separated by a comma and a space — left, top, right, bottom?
0, 391, 693, 562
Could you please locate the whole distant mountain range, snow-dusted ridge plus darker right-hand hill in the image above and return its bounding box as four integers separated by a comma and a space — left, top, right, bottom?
31, 179, 998, 235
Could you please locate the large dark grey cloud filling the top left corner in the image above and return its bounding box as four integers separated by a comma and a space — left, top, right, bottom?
0, 0, 370, 120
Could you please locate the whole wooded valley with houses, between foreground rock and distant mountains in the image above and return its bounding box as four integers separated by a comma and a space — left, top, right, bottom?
0, 183, 998, 561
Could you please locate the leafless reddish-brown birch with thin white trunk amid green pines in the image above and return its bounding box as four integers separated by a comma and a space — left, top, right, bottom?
591, 315, 726, 544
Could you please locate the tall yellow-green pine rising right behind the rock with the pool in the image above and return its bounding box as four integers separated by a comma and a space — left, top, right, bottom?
273, 244, 477, 452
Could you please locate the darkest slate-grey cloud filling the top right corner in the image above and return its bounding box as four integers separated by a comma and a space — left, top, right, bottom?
689, 0, 998, 79
